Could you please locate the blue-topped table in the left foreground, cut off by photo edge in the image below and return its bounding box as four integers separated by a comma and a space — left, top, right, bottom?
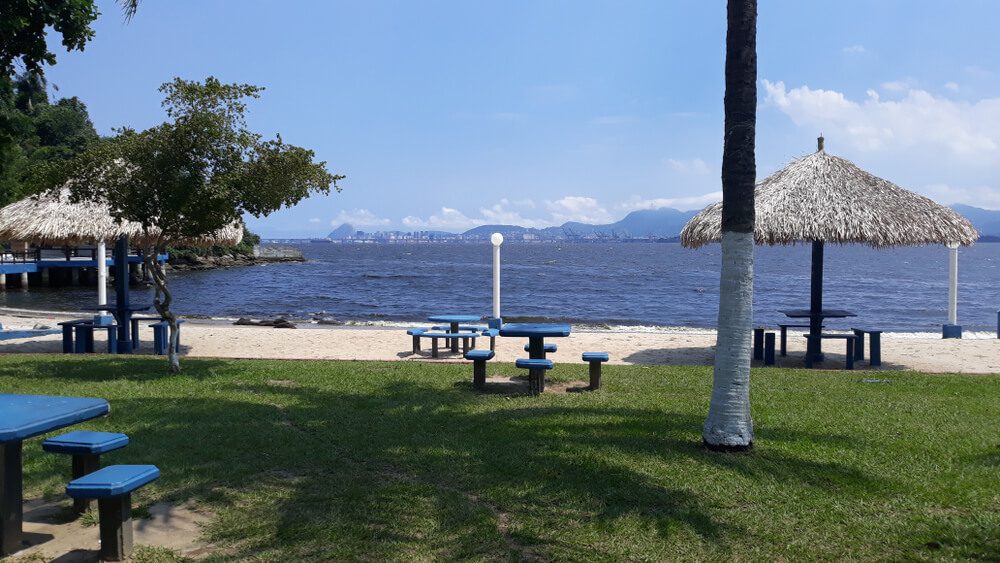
0, 394, 111, 557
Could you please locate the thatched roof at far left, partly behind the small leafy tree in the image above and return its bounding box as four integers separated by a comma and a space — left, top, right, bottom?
0, 189, 243, 246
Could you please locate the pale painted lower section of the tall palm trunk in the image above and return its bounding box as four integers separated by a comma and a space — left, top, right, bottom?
702, 232, 754, 450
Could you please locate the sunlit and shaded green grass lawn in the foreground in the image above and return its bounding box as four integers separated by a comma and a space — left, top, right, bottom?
0, 356, 1000, 561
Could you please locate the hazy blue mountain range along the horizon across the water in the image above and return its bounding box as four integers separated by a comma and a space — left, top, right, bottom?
328, 205, 1000, 241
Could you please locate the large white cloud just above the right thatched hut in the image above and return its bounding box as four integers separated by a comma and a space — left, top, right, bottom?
763, 80, 1000, 159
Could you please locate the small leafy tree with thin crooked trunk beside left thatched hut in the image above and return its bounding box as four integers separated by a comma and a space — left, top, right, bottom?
36, 77, 344, 372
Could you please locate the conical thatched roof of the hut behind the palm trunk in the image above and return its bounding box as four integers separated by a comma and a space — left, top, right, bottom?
681, 149, 979, 248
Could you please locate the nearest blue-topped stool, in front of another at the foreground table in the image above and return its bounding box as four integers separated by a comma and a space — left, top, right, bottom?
66, 465, 160, 561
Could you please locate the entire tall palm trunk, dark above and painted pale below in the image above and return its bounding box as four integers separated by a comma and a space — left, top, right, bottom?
702, 0, 757, 451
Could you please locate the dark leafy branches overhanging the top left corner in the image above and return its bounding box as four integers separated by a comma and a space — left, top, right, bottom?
0, 0, 139, 76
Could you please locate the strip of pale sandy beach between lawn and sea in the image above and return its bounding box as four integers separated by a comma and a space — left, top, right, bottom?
0, 310, 1000, 373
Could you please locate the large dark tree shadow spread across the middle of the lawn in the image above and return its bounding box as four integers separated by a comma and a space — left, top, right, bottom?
17, 372, 891, 560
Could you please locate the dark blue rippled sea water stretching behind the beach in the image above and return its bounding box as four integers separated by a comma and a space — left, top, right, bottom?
0, 243, 1000, 331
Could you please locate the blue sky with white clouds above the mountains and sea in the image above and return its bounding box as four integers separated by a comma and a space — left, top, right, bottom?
43, 0, 1000, 237
